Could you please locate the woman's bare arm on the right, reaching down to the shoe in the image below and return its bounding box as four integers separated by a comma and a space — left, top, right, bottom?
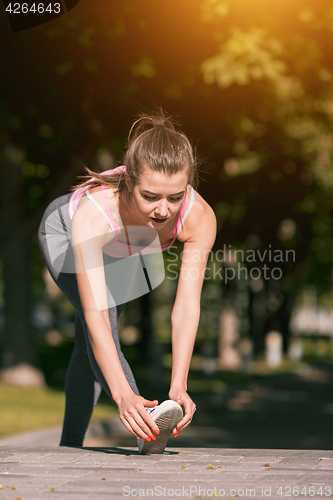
169, 202, 216, 436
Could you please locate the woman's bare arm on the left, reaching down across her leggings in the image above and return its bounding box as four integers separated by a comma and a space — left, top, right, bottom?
72, 200, 158, 440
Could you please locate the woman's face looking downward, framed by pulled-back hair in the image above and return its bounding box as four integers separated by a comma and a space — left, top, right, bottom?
127, 166, 188, 231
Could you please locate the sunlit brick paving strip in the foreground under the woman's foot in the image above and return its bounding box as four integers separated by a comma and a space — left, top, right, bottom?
0, 446, 333, 500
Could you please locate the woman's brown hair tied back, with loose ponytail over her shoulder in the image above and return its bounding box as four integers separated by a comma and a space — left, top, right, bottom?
71, 110, 198, 201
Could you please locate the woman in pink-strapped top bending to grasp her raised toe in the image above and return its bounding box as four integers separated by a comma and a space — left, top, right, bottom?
39, 113, 216, 453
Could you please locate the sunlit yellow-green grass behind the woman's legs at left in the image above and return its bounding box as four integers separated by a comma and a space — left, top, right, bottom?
0, 384, 116, 438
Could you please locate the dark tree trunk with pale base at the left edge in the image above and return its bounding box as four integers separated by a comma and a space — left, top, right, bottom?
0, 143, 44, 385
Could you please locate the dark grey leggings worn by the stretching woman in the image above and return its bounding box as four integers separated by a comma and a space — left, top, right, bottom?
38, 193, 139, 446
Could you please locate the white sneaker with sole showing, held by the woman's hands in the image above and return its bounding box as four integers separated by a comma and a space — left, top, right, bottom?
137, 399, 183, 455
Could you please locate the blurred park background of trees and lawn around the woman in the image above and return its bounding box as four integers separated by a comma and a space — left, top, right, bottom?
0, 0, 333, 449
